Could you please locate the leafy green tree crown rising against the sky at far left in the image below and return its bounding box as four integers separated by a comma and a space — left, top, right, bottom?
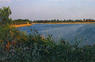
0, 7, 11, 25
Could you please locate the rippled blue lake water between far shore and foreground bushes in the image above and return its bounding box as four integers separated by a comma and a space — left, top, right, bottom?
19, 24, 95, 45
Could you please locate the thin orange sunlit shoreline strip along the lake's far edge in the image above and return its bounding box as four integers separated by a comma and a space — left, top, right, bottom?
11, 22, 95, 28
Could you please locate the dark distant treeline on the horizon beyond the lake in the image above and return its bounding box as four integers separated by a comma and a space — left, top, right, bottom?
12, 19, 95, 24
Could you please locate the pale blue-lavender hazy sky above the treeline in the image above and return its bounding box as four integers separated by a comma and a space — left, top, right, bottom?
0, 0, 95, 20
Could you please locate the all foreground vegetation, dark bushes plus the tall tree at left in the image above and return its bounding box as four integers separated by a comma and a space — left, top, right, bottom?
0, 7, 95, 62
